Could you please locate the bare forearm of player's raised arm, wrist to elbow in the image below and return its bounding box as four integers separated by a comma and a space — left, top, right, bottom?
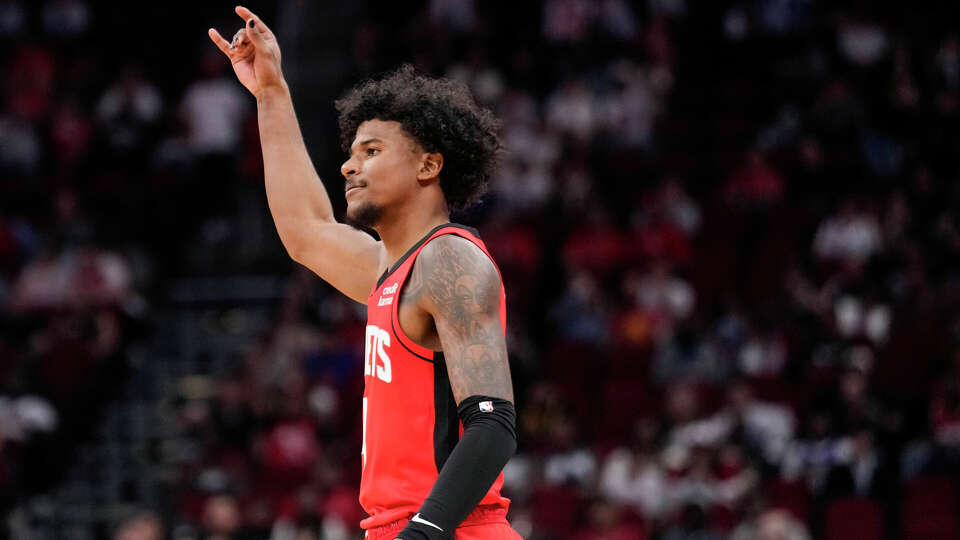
257, 85, 334, 254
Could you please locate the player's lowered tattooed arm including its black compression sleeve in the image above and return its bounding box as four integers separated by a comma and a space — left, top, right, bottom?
398, 235, 517, 540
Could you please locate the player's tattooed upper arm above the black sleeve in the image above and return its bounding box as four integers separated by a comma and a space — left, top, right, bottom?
417, 235, 513, 404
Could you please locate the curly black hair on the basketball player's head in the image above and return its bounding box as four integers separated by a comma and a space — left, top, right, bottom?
335, 64, 503, 210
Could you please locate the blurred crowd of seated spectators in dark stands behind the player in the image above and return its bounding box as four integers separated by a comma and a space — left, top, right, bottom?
0, 0, 960, 540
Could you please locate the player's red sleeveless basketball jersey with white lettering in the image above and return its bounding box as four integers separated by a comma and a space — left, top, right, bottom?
360, 224, 510, 529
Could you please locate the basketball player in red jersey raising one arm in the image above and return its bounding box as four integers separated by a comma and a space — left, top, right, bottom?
209, 7, 519, 540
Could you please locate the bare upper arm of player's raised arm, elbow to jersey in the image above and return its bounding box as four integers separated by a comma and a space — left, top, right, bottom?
290, 220, 384, 304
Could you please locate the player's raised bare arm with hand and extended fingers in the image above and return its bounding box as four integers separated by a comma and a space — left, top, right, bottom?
208, 7, 386, 303
